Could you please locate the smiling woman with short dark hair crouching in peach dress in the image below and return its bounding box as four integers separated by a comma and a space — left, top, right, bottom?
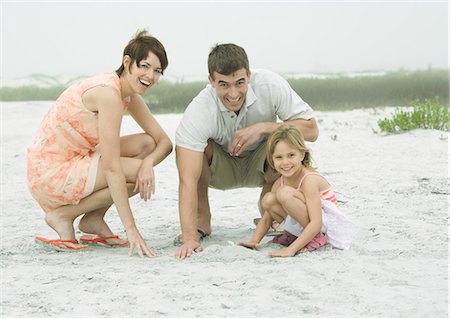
28, 31, 172, 257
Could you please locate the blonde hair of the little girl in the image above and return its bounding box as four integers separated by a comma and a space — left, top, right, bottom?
266, 124, 314, 169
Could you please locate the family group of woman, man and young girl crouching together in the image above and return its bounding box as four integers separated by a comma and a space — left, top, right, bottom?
27, 31, 355, 259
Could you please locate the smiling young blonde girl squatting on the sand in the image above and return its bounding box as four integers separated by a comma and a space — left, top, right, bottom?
240, 125, 356, 257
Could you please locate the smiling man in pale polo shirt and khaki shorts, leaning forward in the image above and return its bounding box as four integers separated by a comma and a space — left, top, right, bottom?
175, 44, 318, 259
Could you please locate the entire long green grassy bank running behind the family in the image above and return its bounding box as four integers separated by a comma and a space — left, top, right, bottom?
0, 70, 449, 113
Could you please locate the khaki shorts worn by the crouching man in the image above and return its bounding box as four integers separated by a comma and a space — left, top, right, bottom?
209, 141, 267, 190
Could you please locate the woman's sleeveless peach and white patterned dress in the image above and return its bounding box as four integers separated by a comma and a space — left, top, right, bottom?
27, 72, 129, 212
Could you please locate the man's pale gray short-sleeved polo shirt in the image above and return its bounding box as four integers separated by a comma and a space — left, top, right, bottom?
175, 70, 314, 152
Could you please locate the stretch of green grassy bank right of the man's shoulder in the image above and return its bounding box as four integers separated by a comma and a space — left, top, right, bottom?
290, 70, 449, 110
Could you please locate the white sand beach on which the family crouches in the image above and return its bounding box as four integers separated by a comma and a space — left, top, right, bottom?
0, 102, 449, 318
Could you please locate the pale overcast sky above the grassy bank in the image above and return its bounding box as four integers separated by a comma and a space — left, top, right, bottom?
1, 0, 449, 79
